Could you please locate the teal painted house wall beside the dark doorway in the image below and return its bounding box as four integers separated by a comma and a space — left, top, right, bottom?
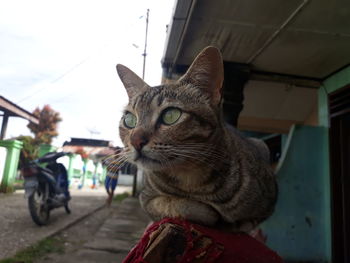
262, 126, 331, 262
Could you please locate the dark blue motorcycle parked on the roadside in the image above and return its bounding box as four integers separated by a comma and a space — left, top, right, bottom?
21, 152, 71, 226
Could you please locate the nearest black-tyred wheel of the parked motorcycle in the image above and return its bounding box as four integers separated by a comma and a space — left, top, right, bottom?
28, 183, 50, 226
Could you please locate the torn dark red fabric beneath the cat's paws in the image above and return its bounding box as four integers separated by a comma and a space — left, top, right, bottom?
123, 218, 283, 263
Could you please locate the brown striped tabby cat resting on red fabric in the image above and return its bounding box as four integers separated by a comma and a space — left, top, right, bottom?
117, 47, 277, 232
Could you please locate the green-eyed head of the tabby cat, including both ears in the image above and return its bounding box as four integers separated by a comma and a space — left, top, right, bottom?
117, 47, 224, 170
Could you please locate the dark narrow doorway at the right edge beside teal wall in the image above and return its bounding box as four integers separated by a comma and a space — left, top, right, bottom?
329, 85, 350, 262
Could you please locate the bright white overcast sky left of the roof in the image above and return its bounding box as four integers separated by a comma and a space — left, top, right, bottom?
0, 0, 174, 146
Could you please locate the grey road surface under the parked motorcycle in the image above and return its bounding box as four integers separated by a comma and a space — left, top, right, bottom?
0, 186, 131, 259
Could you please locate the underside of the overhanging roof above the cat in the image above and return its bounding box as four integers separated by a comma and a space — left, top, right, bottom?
163, 0, 350, 79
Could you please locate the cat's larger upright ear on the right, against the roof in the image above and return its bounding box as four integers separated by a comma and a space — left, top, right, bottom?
179, 46, 224, 105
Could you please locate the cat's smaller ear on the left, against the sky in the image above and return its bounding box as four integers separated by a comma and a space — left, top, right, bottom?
117, 64, 148, 98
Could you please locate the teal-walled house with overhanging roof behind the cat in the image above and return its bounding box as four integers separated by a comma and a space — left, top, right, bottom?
162, 0, 350, 262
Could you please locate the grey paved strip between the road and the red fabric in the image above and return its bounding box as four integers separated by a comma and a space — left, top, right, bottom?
35, 198, 150, 263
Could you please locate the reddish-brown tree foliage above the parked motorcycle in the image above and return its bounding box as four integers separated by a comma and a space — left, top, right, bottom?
27, 105, 62, 144
